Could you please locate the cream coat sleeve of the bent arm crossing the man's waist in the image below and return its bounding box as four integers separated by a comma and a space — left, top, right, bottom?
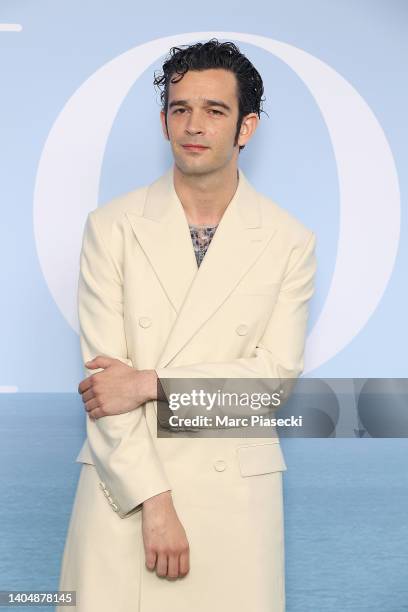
156, 232, 317, 416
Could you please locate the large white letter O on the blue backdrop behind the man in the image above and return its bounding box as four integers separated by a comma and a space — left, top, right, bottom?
34, 32, 400, 373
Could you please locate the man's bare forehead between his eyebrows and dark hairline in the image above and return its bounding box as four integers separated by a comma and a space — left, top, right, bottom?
169, 68, 238, 105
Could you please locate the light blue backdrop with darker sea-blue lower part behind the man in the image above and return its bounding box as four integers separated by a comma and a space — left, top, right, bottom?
0, 0, 408, 612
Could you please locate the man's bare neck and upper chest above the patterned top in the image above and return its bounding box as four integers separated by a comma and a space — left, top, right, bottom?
173, 164, 238, 225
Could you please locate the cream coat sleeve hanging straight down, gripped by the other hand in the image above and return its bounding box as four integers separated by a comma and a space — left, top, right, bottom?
78, 212, 171, 518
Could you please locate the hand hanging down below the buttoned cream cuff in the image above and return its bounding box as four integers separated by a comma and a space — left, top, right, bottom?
142, 491, 190, 578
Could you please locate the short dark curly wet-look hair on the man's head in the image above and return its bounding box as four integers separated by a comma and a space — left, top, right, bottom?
153, 38, 265, 151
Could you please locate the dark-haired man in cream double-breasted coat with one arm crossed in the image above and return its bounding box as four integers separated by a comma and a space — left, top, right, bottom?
60, 40, 316, 612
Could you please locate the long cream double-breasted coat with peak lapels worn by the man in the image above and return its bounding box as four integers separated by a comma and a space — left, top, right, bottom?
59, 168, 316, 612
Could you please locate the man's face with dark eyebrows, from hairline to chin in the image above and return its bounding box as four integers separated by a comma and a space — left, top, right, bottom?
161, 68, 239, 175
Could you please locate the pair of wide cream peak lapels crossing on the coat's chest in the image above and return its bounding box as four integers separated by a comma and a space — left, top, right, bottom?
127, 168, 275, 367
